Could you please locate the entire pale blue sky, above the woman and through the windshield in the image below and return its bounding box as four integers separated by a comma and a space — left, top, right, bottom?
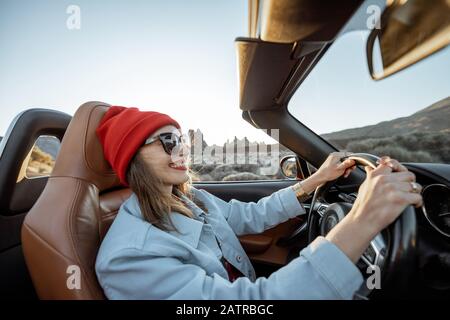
0, 0, 450, 144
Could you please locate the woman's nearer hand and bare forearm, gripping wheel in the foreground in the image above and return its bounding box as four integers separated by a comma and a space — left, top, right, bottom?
326, 157, 422, 262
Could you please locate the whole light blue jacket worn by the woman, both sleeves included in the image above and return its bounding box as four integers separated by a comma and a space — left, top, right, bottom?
95, 187, 363, 300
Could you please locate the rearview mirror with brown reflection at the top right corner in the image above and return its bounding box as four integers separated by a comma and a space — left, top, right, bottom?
366, 0, 450, 80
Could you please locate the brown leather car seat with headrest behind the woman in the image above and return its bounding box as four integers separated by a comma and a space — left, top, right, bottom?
22, 102, 131, 299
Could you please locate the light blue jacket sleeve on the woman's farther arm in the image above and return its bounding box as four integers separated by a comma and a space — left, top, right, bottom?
195, 187, 306, 236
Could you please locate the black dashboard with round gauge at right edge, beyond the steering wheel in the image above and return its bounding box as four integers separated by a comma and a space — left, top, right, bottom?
404, 163, 450, 299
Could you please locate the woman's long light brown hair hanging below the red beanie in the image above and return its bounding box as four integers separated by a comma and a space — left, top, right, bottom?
127, 152, 208, 230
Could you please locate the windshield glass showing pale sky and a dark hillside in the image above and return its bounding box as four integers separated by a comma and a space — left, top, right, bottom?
288, 31, 450, 163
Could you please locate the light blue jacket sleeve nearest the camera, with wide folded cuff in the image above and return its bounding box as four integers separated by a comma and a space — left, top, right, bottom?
97, 237, 363, 300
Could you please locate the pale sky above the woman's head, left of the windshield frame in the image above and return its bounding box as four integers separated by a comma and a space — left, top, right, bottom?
0, 0, 255, 143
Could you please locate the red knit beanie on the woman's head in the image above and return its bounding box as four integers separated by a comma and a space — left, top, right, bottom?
96, 106, 180, 186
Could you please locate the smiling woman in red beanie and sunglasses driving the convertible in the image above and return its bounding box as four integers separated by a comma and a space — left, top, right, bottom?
96, 107, 422, 299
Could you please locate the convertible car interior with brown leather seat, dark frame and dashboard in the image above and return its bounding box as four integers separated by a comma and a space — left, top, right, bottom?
0, 0, 450, 299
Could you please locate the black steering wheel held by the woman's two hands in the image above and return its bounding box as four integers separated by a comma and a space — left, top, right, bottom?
307, 153, 417, 299
